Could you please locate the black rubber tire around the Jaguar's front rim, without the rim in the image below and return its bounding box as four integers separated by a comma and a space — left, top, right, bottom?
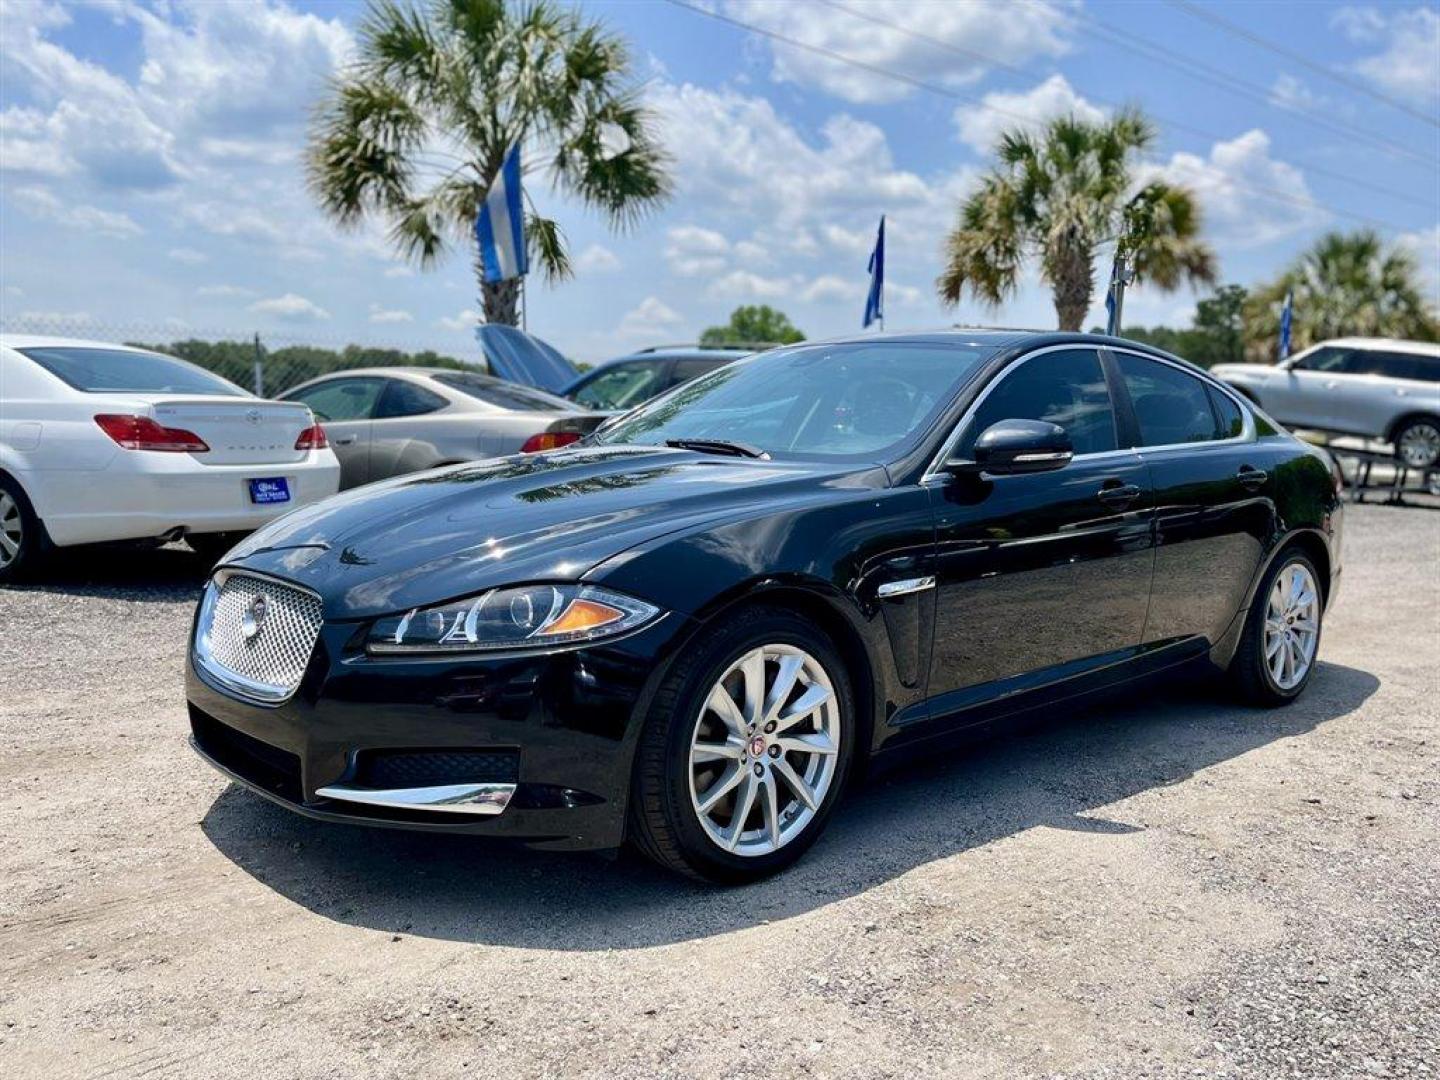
629, 606, 857, 884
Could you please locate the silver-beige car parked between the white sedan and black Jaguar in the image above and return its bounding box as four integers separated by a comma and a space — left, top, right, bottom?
279, 367, 605, 490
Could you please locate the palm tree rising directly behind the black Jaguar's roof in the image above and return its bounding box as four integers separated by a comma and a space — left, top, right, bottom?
936, 109, 1215, 330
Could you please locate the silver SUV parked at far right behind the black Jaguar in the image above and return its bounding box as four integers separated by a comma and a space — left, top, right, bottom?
1210, 337, 1440, 469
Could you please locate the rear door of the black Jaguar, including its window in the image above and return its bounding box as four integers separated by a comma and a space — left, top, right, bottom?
1110, 350, 1276, 651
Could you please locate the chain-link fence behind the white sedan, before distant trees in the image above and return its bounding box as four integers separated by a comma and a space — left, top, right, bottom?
0, 315, 485, 397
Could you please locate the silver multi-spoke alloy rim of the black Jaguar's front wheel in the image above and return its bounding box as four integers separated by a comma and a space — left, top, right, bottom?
690, 645, 841, 855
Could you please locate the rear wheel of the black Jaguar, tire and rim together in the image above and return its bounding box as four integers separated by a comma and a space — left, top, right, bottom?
1230, 549, 1325, 706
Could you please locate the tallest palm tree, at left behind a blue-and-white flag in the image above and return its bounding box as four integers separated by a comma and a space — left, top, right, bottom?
308, 0, 670, 325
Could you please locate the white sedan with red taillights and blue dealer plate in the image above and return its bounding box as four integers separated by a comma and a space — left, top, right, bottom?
0, 334, 340, 582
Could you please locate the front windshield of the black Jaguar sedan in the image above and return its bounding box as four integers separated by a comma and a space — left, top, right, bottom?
596, 341, 992, 459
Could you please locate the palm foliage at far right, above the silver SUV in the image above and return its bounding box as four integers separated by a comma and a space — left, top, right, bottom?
1246, 229, 1440, 357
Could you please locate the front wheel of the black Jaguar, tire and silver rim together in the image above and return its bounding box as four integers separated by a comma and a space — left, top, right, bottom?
631, 608, 855, 884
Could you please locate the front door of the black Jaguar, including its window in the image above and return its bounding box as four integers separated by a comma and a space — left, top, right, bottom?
927, 346, 1153, 721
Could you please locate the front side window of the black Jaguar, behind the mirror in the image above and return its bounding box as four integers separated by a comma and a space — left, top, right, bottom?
956, 348, 1119, 458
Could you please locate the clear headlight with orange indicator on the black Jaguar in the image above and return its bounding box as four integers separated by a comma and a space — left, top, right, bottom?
366, 585, 660, 652
